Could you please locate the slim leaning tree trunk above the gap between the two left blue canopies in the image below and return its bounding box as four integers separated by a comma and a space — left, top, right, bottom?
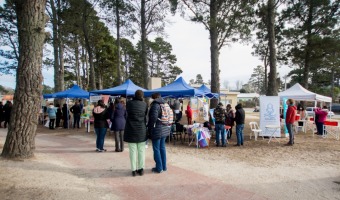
82, 0, 96, 90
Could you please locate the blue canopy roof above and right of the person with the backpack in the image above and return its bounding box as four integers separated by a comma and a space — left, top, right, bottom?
144, 77, 204, 98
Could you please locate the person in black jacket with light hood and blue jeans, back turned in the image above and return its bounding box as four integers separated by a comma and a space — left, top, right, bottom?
92, 100, 110, 152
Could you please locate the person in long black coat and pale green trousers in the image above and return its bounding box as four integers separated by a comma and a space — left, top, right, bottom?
124, 90, 148, 176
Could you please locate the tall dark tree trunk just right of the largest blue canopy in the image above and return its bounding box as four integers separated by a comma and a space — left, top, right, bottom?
209, 0, 220, 108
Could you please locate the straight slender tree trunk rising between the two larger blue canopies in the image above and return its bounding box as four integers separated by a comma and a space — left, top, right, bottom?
141, 0, 149, 88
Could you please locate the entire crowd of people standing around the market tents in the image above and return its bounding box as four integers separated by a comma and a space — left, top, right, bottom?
0, 90, 328, 176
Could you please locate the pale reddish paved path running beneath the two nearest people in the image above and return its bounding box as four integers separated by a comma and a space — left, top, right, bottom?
0, 130, 266, 200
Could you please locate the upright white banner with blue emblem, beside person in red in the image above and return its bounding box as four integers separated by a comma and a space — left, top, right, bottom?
260, 96, 281, 137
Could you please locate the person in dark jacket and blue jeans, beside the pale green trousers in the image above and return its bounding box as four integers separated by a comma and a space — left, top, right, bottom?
148, 93, 170, 173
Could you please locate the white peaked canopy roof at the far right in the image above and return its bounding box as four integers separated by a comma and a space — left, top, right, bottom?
279, 83, 332, 102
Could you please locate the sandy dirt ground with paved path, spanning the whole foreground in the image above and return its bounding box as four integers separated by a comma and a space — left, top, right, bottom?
0, 112, 340, 200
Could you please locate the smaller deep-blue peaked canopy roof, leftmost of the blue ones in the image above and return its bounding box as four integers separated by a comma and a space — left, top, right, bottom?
43, 85, 89, 99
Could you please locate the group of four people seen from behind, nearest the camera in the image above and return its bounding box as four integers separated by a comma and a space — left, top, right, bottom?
92, 90, 171, 176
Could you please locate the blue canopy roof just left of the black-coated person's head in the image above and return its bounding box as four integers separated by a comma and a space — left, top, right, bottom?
90, 79, 146, 97
